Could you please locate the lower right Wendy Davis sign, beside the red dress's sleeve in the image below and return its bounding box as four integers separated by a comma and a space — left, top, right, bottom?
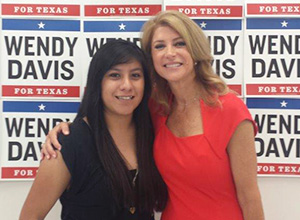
247, 98, 300, 176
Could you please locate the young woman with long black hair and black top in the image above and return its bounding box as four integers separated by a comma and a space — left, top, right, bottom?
20, 40, 167, 220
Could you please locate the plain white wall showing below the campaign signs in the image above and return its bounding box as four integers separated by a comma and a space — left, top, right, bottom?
0, 177, 300, 220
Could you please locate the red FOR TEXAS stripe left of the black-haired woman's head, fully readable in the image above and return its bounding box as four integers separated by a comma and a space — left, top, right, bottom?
2, 85, 80, 98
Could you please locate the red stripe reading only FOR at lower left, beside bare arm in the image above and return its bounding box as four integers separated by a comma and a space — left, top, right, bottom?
1, 167, 38, 179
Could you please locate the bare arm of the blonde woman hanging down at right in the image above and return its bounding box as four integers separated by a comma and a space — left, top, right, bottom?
227, 120, 264, 220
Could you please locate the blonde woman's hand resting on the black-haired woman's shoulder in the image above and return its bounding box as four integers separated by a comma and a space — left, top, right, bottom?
41, 122, 70, 160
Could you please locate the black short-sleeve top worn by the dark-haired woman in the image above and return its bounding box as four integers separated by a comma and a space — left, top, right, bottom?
58, 119, 154, 220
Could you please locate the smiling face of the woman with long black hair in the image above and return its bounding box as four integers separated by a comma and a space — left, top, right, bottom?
102, 60, 145, 116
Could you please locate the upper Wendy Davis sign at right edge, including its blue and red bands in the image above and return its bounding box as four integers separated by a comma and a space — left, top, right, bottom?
244, 10, 300, 97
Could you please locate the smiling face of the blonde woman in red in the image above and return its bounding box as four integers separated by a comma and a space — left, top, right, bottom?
151, 26, 195, 83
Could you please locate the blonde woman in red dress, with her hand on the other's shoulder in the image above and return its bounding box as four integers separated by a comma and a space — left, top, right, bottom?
43, 11, 264, 220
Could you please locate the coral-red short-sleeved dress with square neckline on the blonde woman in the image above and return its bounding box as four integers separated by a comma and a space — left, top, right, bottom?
150, 93, 256, 220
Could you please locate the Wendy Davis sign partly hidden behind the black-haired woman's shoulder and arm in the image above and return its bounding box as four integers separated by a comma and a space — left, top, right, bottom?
0, 100, 80, 180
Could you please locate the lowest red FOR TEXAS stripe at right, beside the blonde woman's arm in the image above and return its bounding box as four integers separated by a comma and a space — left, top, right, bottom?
257, 163, 300, 176
